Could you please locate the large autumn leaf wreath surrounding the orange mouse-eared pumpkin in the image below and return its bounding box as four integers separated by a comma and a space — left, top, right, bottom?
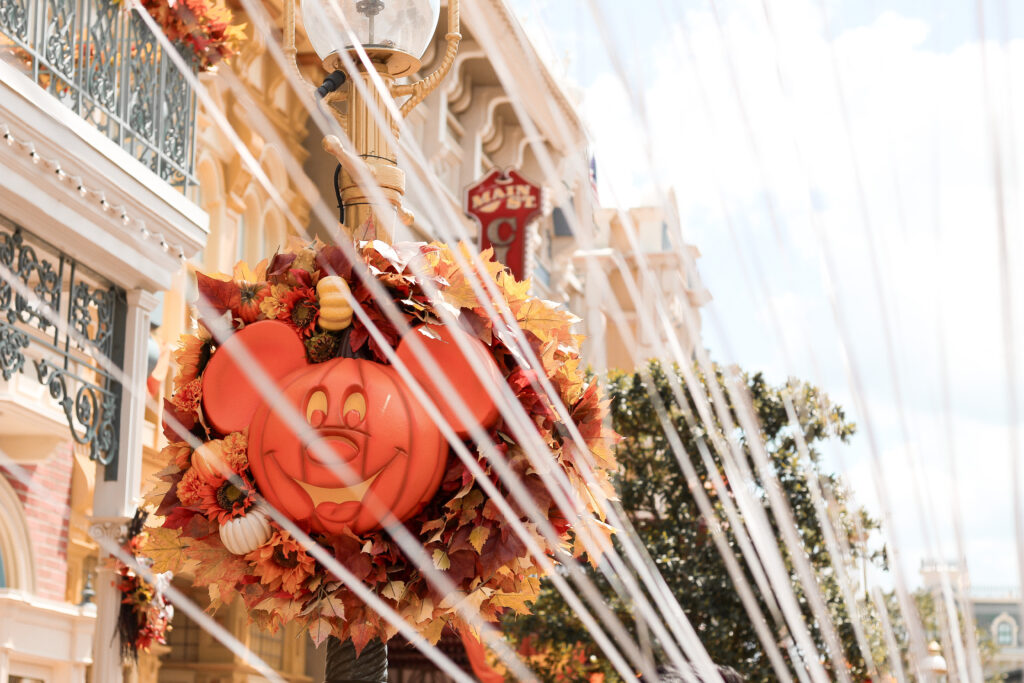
144, 242, 614, 649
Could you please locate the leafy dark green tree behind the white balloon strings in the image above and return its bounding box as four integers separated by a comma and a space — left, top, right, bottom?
504, 361, 879, 682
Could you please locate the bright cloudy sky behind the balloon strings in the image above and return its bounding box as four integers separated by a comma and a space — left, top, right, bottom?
510, 0, 1024, 589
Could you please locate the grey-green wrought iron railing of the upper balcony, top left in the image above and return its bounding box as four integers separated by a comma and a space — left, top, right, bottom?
0, 0, 196, 193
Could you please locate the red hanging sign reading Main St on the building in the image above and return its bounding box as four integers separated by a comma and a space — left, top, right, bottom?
466, 169, 541, 280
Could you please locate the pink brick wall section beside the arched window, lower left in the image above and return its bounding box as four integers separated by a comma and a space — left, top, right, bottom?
3, 443, 73, 600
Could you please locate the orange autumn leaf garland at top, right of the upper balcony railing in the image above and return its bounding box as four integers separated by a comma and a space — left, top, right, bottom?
116, 0, 245, 71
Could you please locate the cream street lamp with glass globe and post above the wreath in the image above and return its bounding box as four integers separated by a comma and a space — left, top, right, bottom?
285, 0, 462, 242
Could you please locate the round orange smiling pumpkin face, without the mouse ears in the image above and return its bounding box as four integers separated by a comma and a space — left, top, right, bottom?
249, 358, 447, 533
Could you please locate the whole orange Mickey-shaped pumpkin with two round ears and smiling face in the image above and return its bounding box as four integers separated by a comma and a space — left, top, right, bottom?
203, 321, 503, 533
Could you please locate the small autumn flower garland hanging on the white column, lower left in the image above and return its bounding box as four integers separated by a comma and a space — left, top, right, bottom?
115, 510, 174, 660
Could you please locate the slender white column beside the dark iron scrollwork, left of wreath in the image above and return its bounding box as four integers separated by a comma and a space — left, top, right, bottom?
89, 290, 157, 683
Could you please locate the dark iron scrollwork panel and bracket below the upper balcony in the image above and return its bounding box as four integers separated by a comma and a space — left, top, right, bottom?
0, 218, 126, 465
